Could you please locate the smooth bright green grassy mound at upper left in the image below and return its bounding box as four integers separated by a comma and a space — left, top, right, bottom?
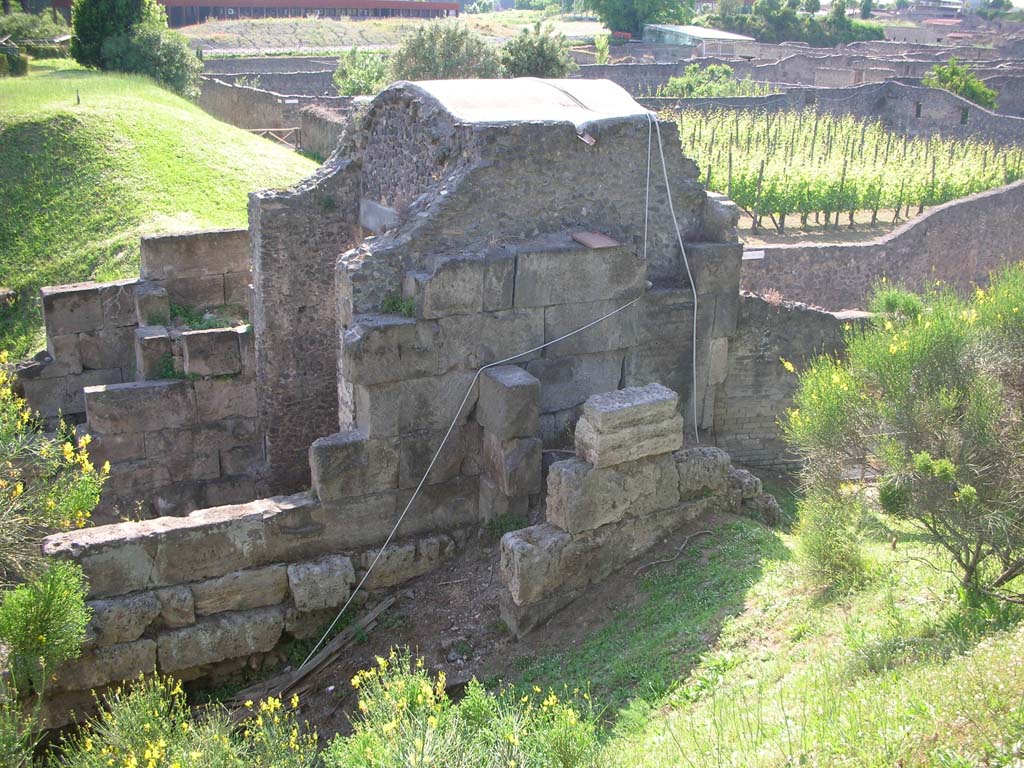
0, 65, 315, 355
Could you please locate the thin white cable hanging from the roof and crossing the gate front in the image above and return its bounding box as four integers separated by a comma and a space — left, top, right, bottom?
298, 113, 699, 670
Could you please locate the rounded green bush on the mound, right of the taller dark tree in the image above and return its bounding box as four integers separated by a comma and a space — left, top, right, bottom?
100, 20, 203, 99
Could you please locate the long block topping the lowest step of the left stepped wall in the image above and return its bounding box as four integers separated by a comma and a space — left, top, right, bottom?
85, 381, 195, 433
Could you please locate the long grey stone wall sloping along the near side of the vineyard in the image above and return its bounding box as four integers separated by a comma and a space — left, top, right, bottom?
740, 181, 1024, 309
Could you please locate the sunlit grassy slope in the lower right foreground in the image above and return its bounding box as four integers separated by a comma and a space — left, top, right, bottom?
512, 489, 1024, 768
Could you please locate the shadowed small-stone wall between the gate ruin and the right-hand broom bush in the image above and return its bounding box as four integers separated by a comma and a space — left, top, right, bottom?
712, 294, 864, 472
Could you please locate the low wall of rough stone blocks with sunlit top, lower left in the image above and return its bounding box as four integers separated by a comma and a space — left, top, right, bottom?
43, 494, 456, 725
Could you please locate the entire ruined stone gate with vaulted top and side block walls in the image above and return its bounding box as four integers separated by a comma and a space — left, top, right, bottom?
26, 79, 840, 720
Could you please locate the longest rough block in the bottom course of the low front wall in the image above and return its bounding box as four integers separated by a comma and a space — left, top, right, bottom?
157, 607, 285, 674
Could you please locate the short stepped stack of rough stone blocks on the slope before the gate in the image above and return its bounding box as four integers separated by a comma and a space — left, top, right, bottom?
501, 384, 773, 636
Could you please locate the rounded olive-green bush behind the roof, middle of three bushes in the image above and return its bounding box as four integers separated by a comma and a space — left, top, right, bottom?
391, 19, 502, 80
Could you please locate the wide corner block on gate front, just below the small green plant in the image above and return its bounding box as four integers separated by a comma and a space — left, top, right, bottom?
340, 314, 437, 384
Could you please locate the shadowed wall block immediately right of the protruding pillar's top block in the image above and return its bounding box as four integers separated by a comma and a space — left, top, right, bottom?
526, 350, 624, 414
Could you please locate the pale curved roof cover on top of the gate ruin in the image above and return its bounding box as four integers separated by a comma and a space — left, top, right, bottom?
403, 78, 650, 130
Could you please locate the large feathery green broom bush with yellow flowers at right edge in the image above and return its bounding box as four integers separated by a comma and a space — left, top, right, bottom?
784, 266, 1024, 601
